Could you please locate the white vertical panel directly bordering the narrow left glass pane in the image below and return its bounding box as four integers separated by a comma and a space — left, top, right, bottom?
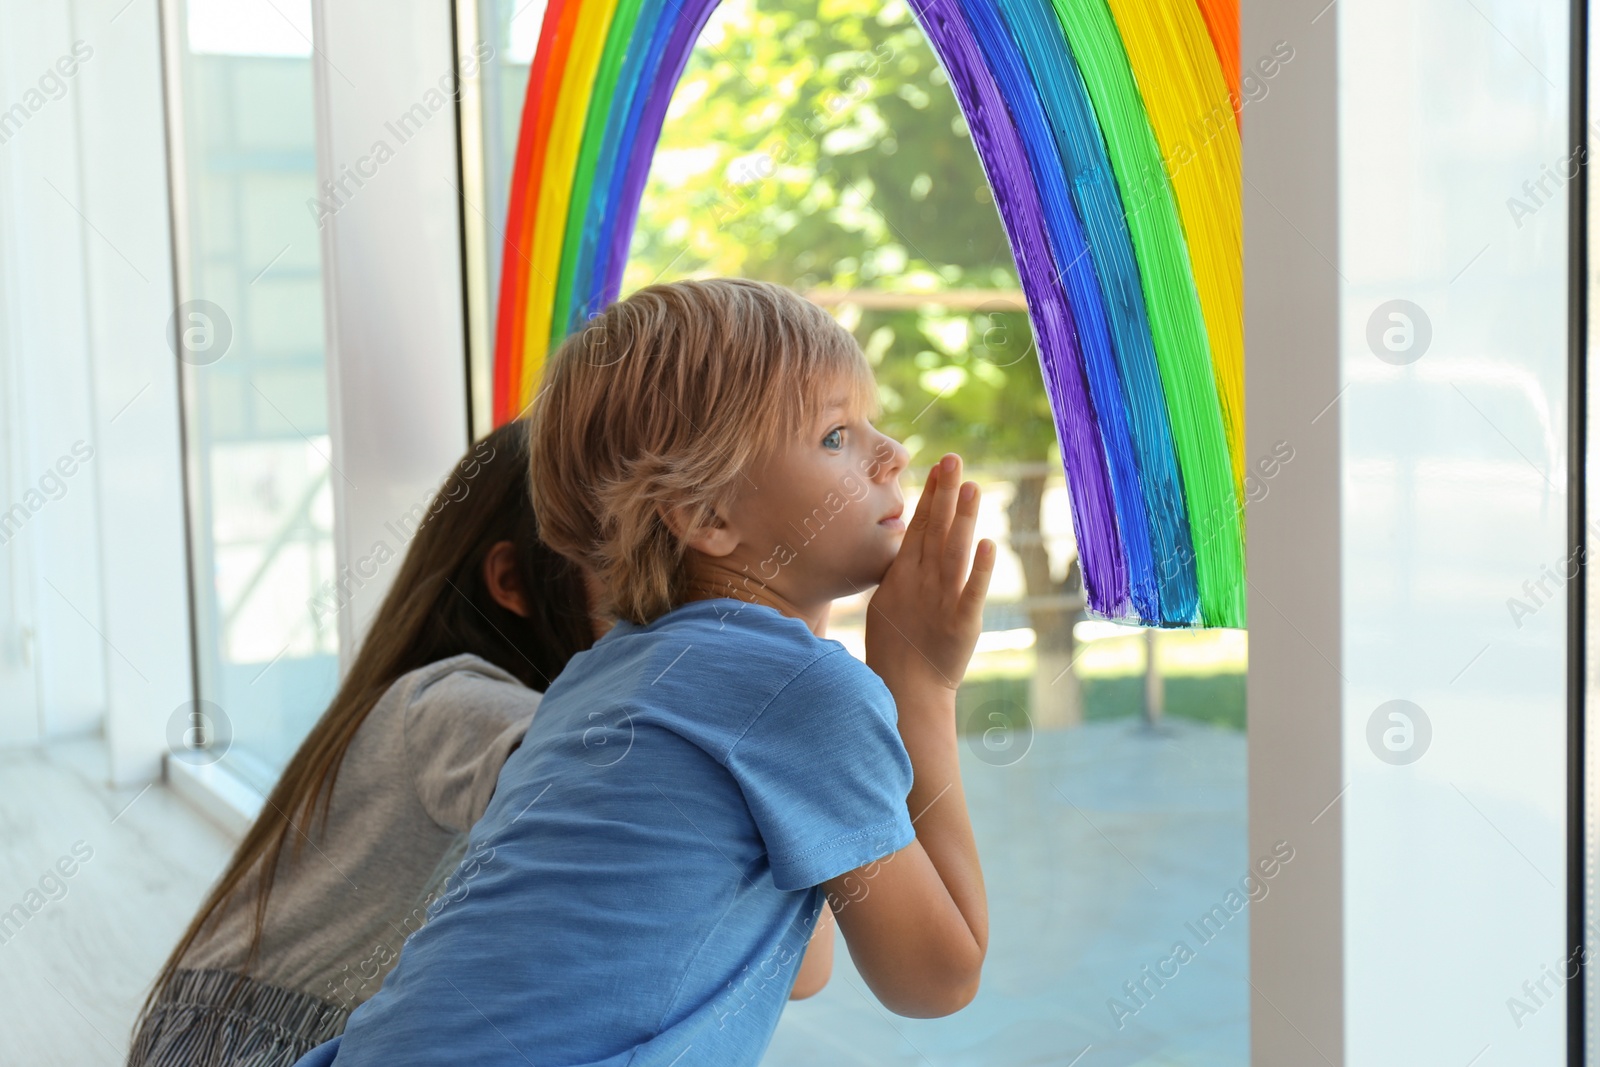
75, 0, 194, 782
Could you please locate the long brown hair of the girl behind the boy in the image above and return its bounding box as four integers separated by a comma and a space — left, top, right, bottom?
134, 419, 594, 1032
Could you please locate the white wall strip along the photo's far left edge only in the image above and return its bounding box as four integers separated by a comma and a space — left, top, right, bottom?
0, 0, 112, 741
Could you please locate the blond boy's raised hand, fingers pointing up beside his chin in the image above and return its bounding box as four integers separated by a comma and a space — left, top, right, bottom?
867, 453, 995, 691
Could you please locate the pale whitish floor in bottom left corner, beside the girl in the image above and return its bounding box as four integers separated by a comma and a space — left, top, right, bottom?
0, 741, 232, 1067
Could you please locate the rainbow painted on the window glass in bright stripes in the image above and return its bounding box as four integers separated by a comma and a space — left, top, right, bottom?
494, 0, 1245, 627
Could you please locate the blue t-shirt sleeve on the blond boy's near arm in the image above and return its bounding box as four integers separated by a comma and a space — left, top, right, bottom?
728, 648, 917, 889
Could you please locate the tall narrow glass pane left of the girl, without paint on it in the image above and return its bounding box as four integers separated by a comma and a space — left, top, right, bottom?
174, 0, 338, 789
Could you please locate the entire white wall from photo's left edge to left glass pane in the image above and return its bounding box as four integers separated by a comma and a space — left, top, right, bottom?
0, 0, 192, 784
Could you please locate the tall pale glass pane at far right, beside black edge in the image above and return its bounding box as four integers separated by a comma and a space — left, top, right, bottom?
1344, 0, 1581, 1067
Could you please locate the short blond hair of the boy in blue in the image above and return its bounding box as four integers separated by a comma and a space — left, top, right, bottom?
528, 278, 878, 625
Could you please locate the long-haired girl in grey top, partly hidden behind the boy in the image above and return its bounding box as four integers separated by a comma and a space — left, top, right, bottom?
128, 421, 605, 1067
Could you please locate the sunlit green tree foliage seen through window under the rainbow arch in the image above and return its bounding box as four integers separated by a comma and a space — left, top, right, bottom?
624, 0, 1056, 467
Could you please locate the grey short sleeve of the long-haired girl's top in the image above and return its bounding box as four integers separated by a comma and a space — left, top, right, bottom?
405, 667, 541, 832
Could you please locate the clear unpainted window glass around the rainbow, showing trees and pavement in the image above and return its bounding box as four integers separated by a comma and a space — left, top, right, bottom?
480, 0, 1264, 1065
